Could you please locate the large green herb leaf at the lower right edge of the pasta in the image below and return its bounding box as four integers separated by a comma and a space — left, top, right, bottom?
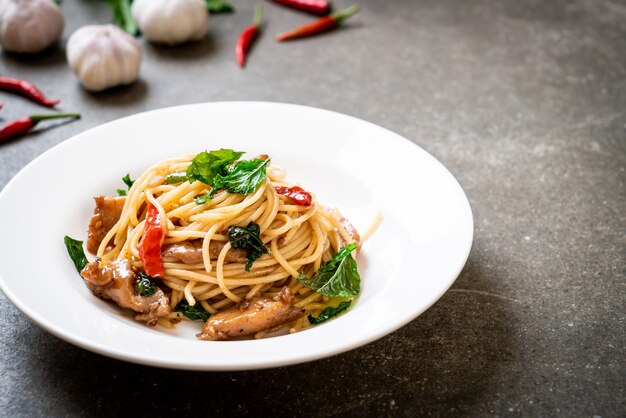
298, 242, 361, 298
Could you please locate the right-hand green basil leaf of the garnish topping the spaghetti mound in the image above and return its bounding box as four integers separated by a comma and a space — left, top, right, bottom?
213, 159, 269, 194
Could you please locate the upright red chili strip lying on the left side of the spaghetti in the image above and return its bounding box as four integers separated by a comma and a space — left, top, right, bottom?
139, 204, 165, 277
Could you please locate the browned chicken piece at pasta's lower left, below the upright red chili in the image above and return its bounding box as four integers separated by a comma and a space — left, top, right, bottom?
80, 260, 171, 325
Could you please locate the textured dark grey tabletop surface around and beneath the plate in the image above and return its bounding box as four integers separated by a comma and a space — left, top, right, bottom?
0, 0, 626, 417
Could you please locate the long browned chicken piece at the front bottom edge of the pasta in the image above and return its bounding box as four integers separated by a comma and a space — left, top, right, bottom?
197, 286, 306, 341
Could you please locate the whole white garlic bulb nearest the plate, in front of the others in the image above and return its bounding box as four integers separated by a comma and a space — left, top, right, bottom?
67, 25, 141, 91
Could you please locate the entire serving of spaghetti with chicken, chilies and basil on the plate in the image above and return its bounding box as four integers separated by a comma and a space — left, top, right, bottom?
66, 149, 361, 340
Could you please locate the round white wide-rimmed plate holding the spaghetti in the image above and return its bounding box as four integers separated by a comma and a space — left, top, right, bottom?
0, 102, 473, 370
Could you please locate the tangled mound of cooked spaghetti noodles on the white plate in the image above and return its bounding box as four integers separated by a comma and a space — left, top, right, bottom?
83, 150, 360, 339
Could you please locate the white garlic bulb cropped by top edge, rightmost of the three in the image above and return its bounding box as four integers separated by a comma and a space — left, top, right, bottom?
131, 0, 209, 45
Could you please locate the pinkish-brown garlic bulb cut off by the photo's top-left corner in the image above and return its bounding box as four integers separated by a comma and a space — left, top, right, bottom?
0, 0, 63, 53
